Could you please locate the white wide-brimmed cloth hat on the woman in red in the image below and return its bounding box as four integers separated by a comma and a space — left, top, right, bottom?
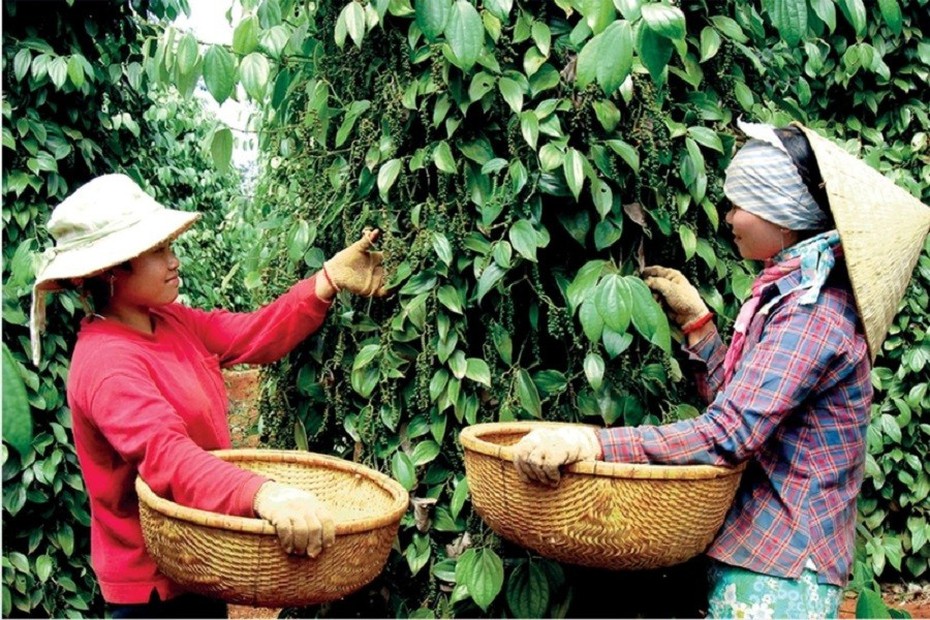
29, 174, 200, 365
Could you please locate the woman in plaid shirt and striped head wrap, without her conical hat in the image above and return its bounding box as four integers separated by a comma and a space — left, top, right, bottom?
515, 123, 872, 618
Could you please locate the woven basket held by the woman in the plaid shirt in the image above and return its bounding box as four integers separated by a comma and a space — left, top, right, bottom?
459, 422, 743, 570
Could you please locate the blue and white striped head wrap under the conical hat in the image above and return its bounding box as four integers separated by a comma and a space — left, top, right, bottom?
723, 121, 827, 230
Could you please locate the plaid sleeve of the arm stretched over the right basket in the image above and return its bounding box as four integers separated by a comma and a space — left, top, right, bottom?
599, 296, 849, 465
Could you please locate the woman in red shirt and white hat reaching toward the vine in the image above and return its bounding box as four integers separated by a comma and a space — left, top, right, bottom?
31, 174, 385, 618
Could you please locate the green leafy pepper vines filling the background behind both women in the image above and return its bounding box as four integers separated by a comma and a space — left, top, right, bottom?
3, 0, 930, 617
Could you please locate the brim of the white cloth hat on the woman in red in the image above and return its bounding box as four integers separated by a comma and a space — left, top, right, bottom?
35, 209, 200, 291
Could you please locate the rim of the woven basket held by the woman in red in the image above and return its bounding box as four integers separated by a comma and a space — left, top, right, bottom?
135, 448, 410, 536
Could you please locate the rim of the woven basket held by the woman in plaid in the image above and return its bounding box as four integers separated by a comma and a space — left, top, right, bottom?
459, 420, 746, 480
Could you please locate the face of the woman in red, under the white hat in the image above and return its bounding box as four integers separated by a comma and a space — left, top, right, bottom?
110, 243, 181, 308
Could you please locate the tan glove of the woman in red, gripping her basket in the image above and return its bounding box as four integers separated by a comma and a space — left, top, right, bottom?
252, 482, 336, 558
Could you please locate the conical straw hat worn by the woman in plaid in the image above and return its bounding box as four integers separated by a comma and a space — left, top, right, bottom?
795, 123, 930, 361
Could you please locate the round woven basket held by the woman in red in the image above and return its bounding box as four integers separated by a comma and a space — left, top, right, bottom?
136, 450, 408, 607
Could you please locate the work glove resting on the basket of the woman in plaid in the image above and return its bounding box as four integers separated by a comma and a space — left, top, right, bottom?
513, 425, 601, 486
